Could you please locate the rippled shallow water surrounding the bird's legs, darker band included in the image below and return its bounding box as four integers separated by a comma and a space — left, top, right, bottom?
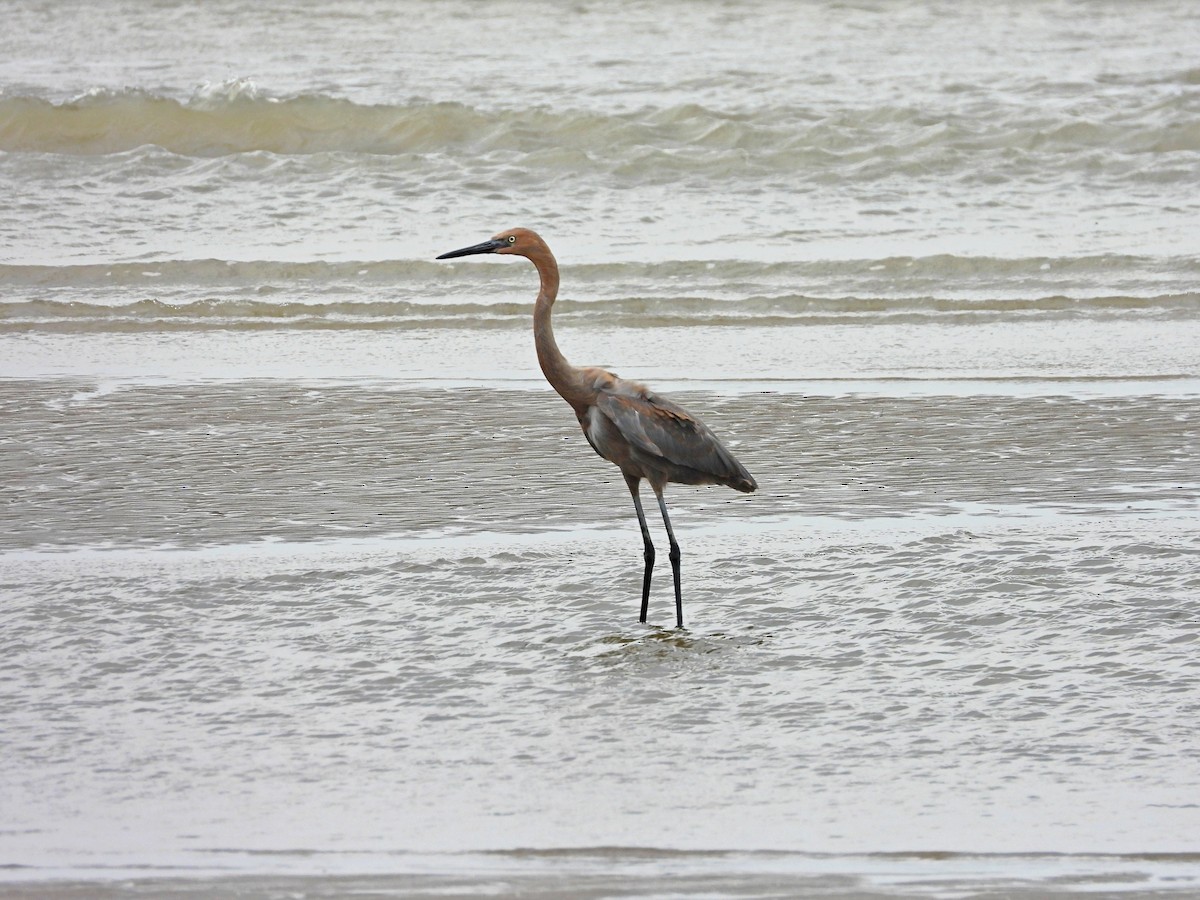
7, 382, 1200, 888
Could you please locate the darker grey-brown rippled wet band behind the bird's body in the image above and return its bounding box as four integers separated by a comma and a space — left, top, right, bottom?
0, 382, 1200, 550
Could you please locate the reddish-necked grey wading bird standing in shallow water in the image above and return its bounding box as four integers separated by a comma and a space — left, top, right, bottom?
438, 228, 758, 628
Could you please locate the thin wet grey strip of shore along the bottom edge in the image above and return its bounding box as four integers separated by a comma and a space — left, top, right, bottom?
5, 847, 1200, 900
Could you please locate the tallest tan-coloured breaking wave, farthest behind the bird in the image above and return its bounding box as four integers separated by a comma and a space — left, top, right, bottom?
0, 80, 1200, 168
